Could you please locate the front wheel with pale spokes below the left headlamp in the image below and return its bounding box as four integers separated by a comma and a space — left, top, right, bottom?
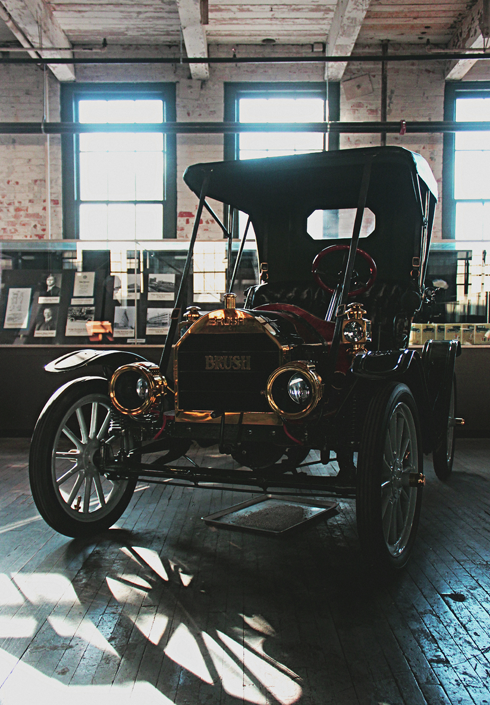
29, 377, 136, 537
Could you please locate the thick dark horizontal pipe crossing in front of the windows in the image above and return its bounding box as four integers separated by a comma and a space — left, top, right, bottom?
0, 120, 490, 135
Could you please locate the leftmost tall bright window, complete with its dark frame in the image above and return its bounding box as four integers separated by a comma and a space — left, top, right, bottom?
62, 84, 176, 241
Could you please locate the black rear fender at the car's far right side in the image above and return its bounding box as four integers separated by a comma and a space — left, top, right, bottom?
422, 340, 461, 445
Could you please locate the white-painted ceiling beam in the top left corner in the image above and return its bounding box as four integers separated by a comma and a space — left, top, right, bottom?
0, 0, 75, 81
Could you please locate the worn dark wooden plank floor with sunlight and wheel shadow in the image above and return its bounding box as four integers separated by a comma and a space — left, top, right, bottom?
0, 439, 490, 705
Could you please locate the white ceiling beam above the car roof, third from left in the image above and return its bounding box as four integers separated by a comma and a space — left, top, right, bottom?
325, 0, 370, 81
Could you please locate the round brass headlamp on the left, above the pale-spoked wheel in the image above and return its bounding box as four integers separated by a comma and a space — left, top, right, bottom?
109, 362, 169, 416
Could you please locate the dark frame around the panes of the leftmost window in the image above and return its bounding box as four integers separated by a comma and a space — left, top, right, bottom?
61, 83, 177, 240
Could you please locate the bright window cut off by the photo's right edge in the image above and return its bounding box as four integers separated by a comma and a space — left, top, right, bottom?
443, 82, 490, 241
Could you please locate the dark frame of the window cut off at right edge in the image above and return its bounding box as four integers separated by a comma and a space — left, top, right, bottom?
442, 81, 490, 242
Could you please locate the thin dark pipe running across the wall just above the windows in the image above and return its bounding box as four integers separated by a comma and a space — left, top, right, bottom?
0, 47, 490, 65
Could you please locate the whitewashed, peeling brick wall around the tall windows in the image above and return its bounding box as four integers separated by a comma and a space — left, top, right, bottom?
0, 46, 483, 240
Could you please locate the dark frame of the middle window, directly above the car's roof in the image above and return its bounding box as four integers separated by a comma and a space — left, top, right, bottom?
224, 81, 340, 159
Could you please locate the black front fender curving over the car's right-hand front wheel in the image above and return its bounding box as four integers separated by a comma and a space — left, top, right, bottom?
352, 349, 435, 454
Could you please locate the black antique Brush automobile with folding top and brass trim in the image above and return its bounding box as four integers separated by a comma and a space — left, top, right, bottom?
30, 147, 460, 568
